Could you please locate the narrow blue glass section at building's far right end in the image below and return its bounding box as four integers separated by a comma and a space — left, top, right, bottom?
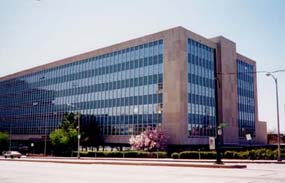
237, 60, 255, 137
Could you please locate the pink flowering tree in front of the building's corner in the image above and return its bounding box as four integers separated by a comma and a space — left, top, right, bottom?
129, 127, 168, 151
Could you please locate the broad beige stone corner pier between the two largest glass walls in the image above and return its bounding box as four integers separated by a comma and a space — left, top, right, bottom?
163, 27, 187, 144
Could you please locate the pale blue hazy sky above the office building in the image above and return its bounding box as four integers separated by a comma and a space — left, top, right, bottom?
0, 0, 285, 133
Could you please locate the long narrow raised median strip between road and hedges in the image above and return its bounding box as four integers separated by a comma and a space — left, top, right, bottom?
0, 157, 246, 168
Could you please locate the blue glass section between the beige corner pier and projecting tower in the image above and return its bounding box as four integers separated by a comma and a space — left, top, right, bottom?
187, 39, 216, 137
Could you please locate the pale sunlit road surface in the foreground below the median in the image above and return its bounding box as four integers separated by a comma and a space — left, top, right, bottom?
0, 161, 285, 183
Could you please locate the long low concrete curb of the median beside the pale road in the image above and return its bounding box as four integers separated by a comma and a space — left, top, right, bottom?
0, 159, 244, 169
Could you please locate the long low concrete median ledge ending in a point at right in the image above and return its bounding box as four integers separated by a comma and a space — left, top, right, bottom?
0, 158, 244, 168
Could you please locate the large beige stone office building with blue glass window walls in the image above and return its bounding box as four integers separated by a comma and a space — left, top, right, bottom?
0, 27, 266, 148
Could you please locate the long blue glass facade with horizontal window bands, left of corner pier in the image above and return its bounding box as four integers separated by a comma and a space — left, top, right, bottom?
0, 40, 163, 135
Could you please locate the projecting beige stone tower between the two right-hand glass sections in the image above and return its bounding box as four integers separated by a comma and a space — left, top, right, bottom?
211, 37, 239, 144
